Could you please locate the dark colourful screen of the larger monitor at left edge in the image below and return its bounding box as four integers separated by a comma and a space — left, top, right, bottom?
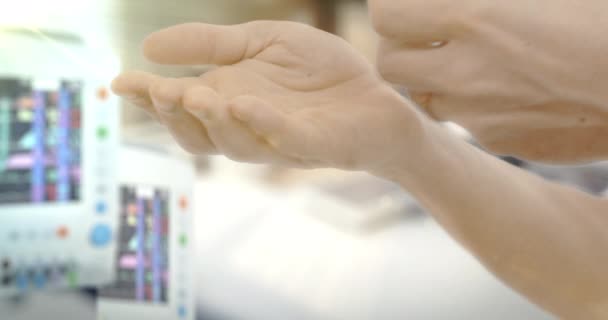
0, 77, 82, 205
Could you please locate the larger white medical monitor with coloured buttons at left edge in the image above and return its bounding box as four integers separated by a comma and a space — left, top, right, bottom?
0, 29, 119, 295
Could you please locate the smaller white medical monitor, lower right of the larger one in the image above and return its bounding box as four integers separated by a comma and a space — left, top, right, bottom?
98, 147, 195, 320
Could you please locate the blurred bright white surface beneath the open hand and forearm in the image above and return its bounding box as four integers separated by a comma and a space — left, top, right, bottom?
196, 172, 551, 320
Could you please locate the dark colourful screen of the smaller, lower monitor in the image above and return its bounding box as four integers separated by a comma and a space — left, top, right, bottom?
101, 186, 170, 303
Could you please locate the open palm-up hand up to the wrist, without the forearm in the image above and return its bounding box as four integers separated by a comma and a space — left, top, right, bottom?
113, 21, 421, 169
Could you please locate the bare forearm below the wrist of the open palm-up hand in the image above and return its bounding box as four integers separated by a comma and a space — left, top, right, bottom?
375, 94, 608, 319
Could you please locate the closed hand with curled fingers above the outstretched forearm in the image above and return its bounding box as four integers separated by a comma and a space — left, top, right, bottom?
369, 0, 608, 162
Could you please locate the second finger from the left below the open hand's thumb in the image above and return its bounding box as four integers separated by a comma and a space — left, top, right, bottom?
149, 79, 216, 154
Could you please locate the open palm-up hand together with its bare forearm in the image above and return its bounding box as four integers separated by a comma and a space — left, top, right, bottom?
113, 22, 608, 319
